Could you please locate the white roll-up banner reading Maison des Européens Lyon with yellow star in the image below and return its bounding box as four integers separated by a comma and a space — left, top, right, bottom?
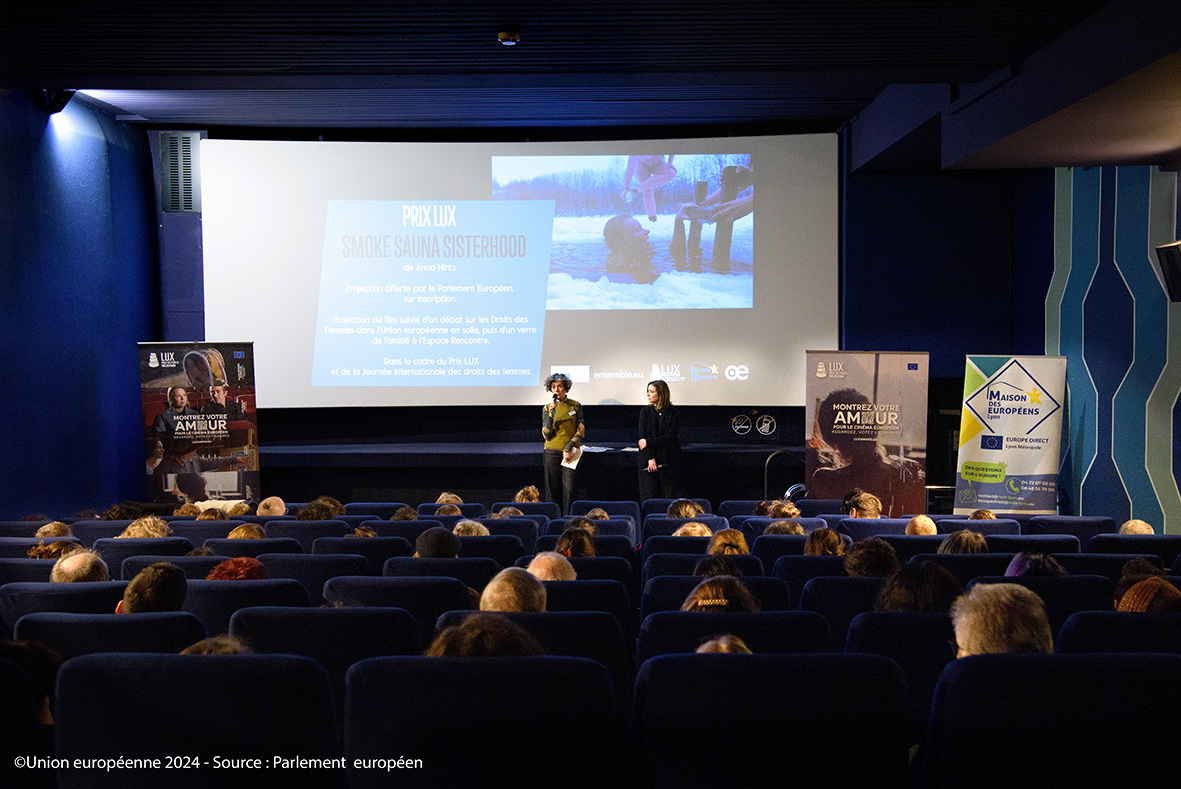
955, 356, 1066, 515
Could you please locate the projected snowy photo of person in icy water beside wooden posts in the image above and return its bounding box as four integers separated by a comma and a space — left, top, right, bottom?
492, 154, 755, 311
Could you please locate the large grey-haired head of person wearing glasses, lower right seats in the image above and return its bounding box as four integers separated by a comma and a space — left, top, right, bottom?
952, 583, 1053, 658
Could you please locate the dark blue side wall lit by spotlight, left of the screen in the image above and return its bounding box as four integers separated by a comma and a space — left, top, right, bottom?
0, 91, 159, 519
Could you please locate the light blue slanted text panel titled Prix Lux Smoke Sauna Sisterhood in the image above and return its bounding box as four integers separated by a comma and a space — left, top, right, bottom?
312, 201, 554, 386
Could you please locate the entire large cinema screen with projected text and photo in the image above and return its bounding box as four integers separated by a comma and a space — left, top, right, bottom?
198, 135, 840, 409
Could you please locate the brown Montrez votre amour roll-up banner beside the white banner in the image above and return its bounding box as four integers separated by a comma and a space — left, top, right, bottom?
804, 351, 927, 517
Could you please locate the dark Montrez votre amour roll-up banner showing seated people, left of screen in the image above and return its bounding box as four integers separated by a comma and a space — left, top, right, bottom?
139, 343, 260, 504
